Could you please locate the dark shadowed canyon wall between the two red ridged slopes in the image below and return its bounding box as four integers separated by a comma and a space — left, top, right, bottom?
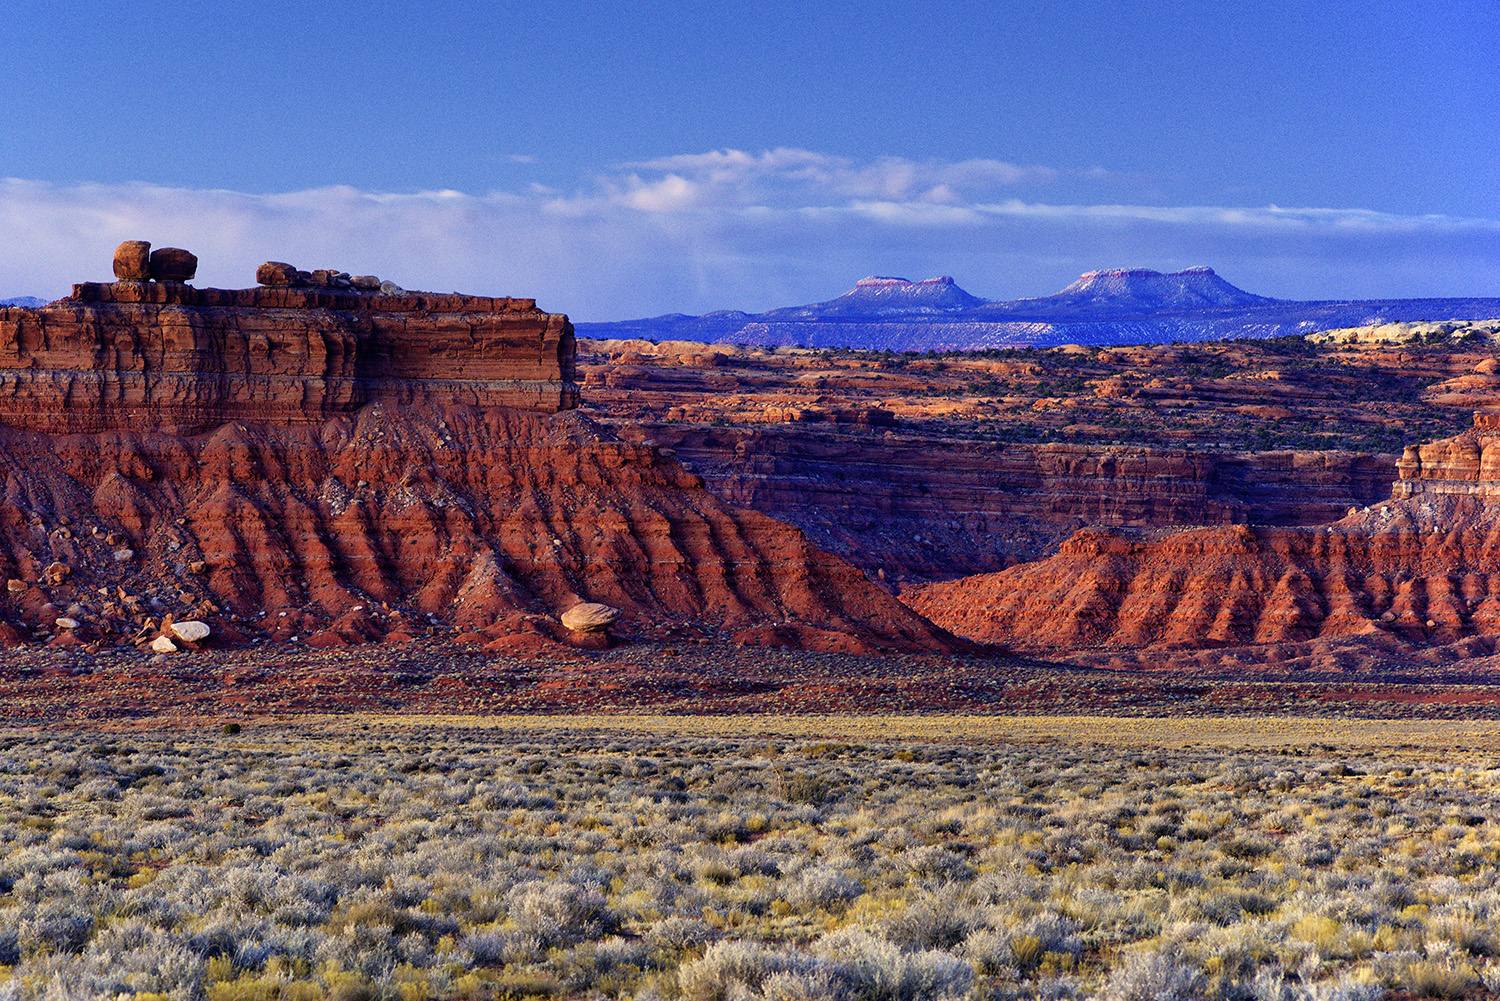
621, 423, 1397, 584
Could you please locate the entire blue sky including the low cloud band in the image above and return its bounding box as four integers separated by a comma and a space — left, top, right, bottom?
0, 0, 1500, 320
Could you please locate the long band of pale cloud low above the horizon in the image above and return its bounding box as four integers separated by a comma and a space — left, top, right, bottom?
0, 149, 1500, 320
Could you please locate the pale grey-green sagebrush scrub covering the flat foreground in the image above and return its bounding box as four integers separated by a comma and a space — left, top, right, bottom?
0, 726, 1500, 1001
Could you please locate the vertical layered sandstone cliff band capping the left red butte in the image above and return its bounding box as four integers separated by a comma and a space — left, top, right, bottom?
0, 281, 578, 434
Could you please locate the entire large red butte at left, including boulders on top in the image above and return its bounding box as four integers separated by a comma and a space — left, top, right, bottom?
0, 262, 971, 653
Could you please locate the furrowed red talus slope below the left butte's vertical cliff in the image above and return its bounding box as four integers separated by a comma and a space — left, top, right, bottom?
0, 404, 963, 650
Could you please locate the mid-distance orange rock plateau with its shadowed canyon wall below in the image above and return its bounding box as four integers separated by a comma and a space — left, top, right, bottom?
579, 323, 1500, 585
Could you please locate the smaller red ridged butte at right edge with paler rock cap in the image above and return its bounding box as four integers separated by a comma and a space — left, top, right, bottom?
906, 417, 1500, 663
